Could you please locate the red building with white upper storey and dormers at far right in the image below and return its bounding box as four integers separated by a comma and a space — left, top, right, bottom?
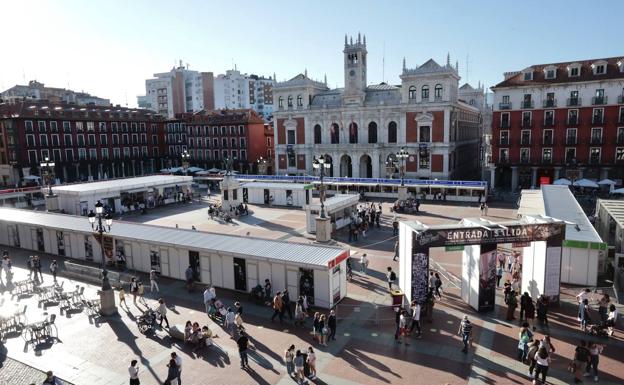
491, 57, 624, 190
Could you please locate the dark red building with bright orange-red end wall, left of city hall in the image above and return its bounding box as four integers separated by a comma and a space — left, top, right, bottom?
165, 109, 273, 173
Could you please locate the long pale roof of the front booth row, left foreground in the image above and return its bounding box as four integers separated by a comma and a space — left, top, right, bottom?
0, 207, 345, 268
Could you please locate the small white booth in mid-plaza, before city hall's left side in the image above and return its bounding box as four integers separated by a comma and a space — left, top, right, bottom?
241, 182, 313, 208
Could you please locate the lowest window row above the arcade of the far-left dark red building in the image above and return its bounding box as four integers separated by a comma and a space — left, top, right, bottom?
28, 146, 159, 164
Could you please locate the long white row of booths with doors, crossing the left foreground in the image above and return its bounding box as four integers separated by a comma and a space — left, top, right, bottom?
0, 208, 349, 308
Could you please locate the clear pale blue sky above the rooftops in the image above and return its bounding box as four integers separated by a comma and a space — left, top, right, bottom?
0, 0, 624, 106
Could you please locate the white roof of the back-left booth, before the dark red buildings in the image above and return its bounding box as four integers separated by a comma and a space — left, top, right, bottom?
52, 175, 193, 194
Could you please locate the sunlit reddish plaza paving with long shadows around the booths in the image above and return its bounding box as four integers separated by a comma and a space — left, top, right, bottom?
0, 203, 624, 385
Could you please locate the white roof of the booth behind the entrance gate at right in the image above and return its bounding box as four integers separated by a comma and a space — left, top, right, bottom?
518, 185, 602, 243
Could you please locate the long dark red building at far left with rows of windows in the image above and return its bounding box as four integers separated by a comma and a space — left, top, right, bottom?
0, 100, 165, 186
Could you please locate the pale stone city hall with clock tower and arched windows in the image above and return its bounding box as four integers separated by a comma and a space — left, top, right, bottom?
273, 34, 482, 179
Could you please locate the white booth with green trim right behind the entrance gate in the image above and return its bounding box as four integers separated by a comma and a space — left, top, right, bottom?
518, 185, 607, 286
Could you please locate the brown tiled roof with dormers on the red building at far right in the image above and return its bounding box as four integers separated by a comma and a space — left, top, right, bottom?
492, 57, 624, 88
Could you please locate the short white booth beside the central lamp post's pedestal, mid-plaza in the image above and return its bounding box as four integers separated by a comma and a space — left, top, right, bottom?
306, 194, 360, 234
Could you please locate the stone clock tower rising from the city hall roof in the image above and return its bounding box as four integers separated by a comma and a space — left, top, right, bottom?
342, 33, 367, 105
